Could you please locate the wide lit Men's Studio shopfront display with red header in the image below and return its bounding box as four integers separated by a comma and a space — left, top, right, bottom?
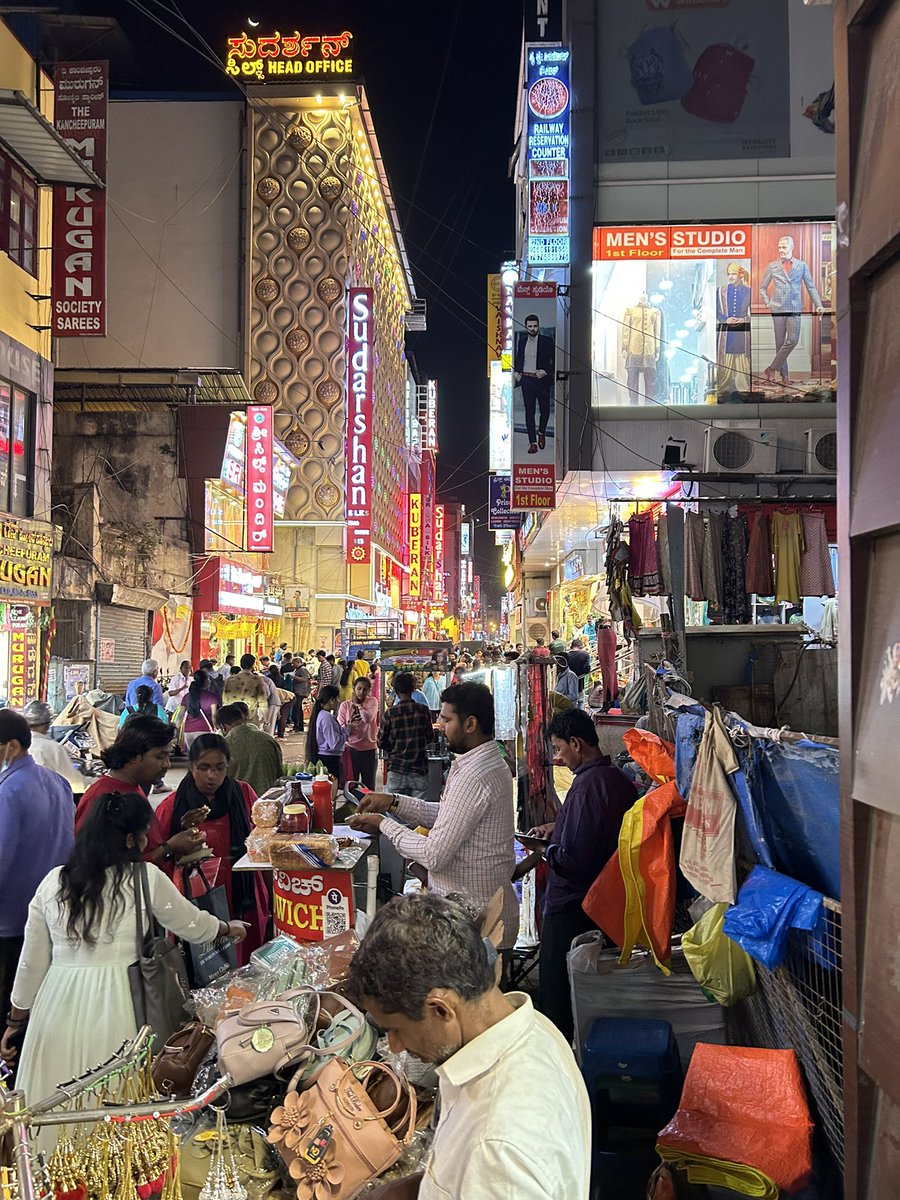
592, 222, 836, 406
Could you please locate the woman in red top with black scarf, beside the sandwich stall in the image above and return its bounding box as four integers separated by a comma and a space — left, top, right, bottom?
146, 733, 269, 966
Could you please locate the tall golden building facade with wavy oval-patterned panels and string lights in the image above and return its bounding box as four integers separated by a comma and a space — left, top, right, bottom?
245, 75, 424, 649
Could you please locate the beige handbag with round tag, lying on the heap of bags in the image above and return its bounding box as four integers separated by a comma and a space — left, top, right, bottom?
216, 988, 310, 1084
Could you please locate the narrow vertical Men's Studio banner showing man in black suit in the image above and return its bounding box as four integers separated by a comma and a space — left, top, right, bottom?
510, 281, 557, 512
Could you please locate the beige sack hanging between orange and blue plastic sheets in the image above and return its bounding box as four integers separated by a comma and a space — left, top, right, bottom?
680, 709, 738, 904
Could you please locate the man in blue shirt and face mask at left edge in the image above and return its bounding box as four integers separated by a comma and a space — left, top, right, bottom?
0, 708, 74, 1051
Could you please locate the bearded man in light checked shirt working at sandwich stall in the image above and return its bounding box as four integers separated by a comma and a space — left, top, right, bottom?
350, 683, 518, 948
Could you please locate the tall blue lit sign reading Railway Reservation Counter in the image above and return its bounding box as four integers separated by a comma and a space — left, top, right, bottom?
526, 46, 570, 266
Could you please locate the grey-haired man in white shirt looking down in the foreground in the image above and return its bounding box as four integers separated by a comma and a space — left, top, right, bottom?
348, 894, 590, 1200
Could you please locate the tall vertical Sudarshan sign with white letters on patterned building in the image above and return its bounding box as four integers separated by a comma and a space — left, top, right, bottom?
344, 288, 374, 563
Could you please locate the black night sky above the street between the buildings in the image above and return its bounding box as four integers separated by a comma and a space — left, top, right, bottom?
54, 0, 522, 601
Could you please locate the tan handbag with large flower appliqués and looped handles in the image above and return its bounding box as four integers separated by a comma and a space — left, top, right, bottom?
269, 1058, 415, 1200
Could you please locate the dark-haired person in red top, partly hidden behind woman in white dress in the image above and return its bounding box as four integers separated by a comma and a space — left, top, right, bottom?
74, 715, 203, 866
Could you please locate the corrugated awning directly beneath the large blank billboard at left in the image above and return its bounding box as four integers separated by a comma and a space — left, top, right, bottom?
53, 367, 252, 412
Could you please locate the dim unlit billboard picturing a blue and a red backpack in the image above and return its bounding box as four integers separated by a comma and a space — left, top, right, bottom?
596, 0, 791, 163
